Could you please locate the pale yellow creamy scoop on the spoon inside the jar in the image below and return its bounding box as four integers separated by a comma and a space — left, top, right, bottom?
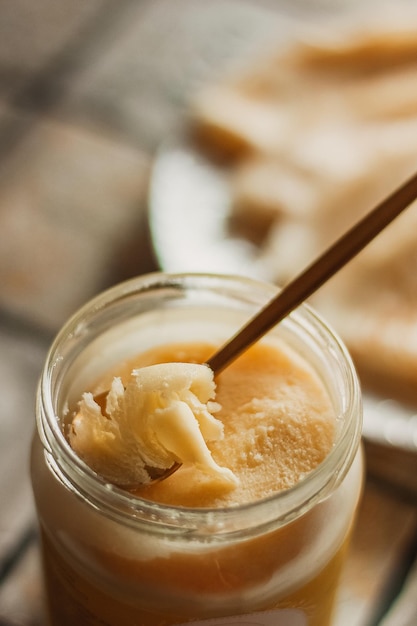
69, 363, 238, 489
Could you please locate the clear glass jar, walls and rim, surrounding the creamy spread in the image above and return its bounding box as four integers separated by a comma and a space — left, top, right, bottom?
31, 273, 362, 626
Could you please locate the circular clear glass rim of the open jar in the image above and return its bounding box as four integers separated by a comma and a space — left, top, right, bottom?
37, 272, 362, 536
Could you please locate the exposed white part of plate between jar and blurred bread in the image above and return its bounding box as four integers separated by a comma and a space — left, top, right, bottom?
149, 142, 267, 278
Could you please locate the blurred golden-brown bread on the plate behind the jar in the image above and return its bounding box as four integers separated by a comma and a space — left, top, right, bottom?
193, 10, 417, 388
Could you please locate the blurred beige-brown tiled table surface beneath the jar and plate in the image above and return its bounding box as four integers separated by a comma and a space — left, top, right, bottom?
0, 0, 417, 626
